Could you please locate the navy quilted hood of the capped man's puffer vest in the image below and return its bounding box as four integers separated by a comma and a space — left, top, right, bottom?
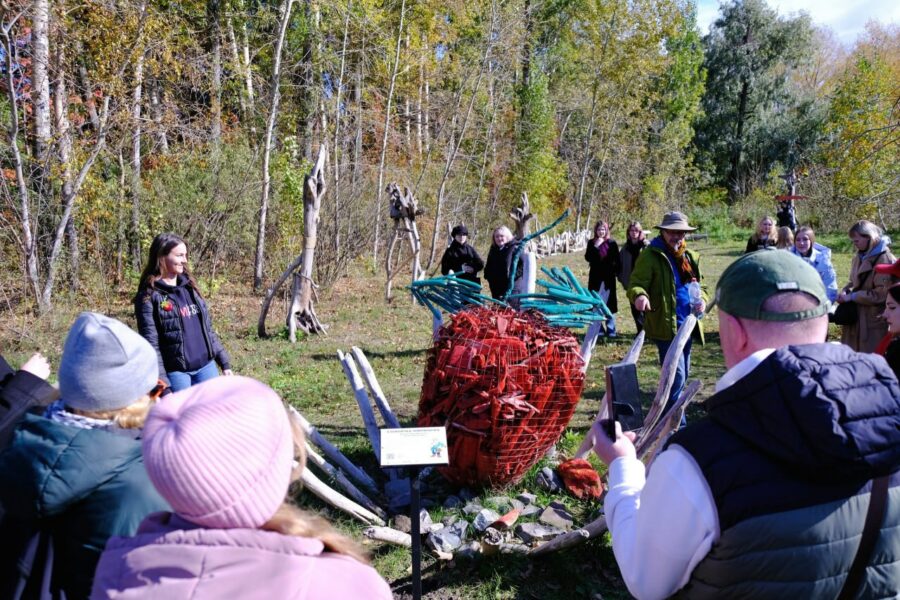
707, 344, 900, 481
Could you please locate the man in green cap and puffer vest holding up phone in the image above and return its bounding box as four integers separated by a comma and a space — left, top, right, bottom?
592, 250, 900, 598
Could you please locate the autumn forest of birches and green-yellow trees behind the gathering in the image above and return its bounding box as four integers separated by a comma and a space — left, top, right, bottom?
0, 0, 900, 314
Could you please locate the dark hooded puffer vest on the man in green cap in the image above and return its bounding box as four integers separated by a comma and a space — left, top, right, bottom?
669, 344, 900, 598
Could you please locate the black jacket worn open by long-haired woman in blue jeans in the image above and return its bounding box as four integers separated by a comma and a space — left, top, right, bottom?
134, 275, 231, 383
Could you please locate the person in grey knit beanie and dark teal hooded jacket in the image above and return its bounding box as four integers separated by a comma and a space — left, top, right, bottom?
0, 312, 169, 599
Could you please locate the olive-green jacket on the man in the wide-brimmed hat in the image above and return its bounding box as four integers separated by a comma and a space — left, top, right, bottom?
627, 245, 709, 344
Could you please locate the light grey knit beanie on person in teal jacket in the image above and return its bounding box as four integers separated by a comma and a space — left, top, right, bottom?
59, 312, 159, 411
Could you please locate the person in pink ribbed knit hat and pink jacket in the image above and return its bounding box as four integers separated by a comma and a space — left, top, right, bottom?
91, 376, 391, 600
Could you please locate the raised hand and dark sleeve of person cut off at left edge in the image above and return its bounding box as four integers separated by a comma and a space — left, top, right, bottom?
0, 352, 59, 450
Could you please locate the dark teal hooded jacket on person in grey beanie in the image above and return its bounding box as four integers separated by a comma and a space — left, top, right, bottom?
0, 415, 170, 599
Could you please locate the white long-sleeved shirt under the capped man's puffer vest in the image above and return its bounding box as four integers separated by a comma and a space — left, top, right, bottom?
604, 348, 774, 600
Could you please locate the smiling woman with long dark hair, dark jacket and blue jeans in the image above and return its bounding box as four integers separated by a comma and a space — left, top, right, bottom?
134, 233, 232, 392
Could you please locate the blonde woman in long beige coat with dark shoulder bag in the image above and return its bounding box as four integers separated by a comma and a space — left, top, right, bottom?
837, 221, 894, 352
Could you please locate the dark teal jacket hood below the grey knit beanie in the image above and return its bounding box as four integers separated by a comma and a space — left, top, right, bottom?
0, 415, 143, 518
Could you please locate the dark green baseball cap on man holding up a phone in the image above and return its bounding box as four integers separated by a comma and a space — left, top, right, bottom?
709, 248, 829, 321
